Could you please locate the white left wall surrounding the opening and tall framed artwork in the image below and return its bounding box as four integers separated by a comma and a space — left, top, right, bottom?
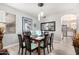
0, 4, 37, 46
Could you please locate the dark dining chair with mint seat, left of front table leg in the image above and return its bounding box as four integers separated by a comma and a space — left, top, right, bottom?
24, 32, 38, 55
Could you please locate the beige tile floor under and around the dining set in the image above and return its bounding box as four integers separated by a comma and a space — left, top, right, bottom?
7, 37, 76, 55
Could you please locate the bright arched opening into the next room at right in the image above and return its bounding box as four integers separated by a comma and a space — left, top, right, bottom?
61, 14, 77, 39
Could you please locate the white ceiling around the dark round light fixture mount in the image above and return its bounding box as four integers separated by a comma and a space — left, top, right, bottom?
2, 3, 79, 17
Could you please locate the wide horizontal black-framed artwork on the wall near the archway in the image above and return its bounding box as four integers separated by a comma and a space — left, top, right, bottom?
41, 21, 55, 31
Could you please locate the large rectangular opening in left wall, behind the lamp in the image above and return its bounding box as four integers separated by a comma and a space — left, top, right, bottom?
0, 10, 16, 33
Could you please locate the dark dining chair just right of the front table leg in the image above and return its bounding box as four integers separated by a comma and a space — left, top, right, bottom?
40, 34, 50, 55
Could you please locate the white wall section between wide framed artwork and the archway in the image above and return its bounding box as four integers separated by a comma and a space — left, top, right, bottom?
41, 15, 61, 41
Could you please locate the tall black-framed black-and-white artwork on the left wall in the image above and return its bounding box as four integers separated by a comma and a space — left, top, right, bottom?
22, 17, 32, 32
